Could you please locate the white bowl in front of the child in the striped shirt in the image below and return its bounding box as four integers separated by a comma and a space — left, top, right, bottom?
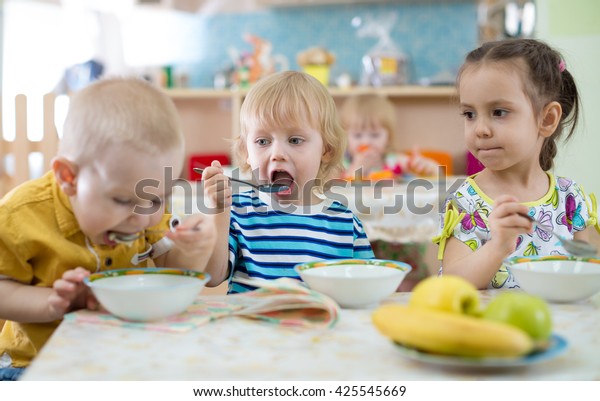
295, 259, 412, 308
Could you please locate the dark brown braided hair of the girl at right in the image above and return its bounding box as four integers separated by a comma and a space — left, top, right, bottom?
457, 39, 580, 171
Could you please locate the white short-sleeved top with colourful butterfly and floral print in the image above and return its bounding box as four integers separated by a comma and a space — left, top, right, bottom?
433, 173, 600, 288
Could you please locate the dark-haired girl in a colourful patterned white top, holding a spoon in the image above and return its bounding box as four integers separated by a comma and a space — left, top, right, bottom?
434, 39, 600, 289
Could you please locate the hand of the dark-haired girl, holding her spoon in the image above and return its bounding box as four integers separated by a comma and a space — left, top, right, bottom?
488, 195, 533, 254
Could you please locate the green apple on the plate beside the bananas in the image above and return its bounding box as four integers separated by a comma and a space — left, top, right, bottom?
482, 291, 552, 341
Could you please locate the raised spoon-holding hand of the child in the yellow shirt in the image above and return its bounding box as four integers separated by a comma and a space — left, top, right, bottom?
165, 214, 217, 256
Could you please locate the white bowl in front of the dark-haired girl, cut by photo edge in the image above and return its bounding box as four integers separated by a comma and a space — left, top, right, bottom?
506, 255, 600, 302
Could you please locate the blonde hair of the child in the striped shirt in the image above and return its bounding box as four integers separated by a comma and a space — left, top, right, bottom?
233, 71, 347, 180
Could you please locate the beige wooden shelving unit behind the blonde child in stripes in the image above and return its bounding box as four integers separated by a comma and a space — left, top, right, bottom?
166, 86, 466, 177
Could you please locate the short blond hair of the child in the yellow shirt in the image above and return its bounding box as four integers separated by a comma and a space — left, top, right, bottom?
58, 78, 184, 163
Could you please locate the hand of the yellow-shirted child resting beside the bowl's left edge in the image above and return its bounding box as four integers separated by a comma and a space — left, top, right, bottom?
48, 267, 98, 320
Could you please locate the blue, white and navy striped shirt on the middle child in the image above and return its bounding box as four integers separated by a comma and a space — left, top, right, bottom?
229, 191, 374, 293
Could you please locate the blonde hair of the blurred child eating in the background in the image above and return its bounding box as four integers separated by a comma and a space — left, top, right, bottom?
340, 94, 397, 151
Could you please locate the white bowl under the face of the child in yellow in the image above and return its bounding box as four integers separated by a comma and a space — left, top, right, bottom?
84, 267, 210, 321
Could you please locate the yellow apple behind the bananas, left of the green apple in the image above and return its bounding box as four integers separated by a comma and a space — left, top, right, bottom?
409, 276, 480, 315
